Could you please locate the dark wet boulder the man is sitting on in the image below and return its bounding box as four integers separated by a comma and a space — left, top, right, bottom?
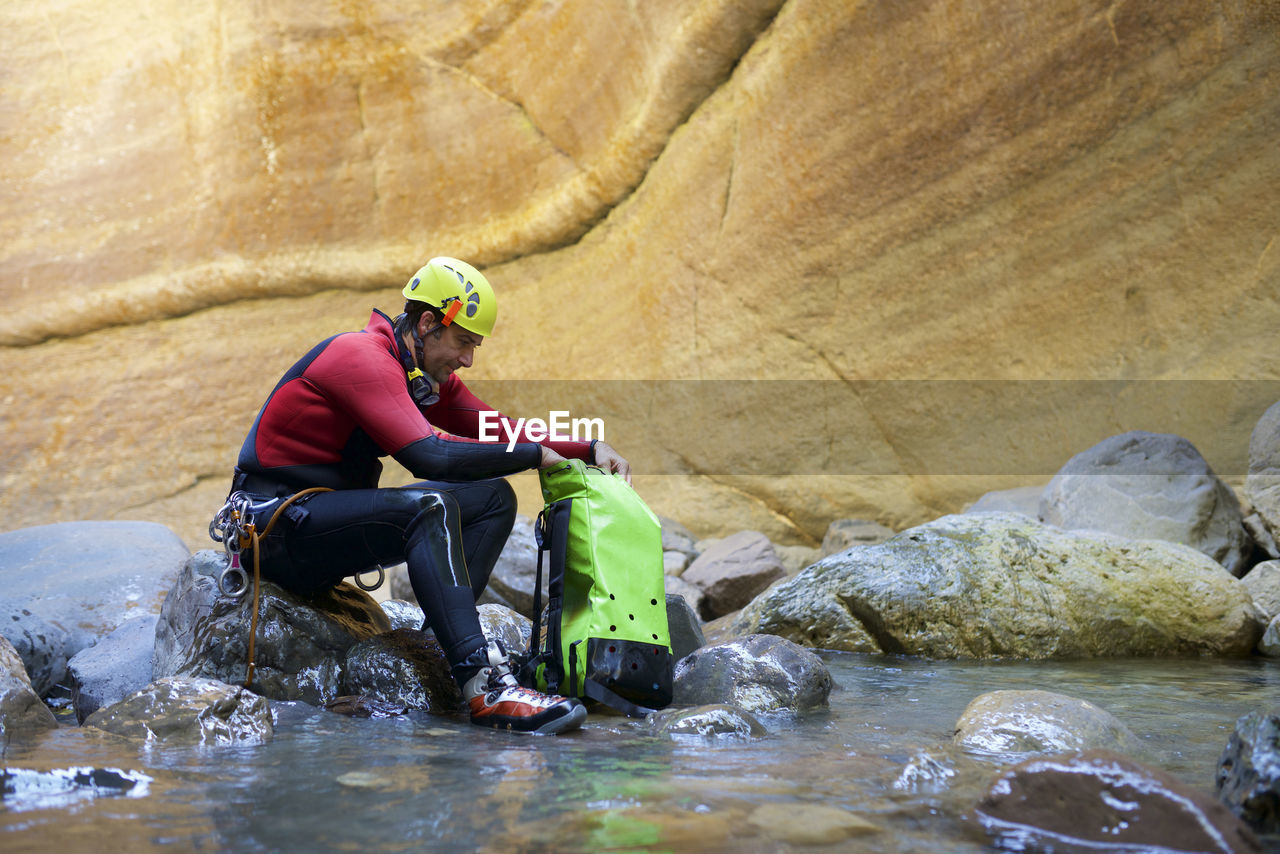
152, 551, 390, 705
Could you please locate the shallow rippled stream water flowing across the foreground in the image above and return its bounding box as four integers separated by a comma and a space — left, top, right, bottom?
0, 653, 1280, 854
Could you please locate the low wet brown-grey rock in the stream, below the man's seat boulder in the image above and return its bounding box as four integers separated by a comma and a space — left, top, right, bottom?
84, 677, 273, 744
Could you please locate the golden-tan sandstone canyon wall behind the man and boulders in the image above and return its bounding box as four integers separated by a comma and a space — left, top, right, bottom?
0, 0, 1280, 547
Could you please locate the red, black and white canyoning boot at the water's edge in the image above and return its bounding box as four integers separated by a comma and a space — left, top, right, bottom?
462, 643, 586, 735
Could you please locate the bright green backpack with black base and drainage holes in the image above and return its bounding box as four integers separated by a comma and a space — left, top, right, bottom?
521, 460, 675, 716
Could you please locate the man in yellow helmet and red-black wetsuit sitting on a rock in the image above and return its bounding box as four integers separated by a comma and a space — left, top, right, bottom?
232, 257, 631, 732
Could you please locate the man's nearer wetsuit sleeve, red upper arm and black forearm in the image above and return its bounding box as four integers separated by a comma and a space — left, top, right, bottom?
306, 339, 541, 481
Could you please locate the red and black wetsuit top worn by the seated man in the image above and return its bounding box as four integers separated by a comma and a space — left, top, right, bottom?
237, 310, 591, 492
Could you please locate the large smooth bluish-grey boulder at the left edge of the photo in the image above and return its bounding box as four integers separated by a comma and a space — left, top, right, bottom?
0, 521, 191, 665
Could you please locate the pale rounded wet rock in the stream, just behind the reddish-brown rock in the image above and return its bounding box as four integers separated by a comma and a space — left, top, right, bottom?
952, 691, 1142, 755
